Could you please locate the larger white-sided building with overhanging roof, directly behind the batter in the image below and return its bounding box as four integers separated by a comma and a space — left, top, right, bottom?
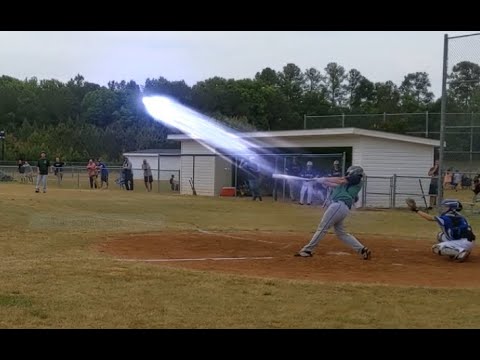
168, 128, 440, 207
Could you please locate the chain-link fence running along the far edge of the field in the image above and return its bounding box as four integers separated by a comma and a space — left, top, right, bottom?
0, 159, 480, 212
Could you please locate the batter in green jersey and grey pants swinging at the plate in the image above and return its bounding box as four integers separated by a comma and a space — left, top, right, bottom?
295, 166, 371, 260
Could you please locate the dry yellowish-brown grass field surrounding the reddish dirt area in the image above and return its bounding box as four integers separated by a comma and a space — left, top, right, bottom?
0, 183, 480, 328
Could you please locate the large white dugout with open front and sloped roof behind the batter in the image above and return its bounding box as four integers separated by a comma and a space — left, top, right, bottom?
168, 128, 440, 207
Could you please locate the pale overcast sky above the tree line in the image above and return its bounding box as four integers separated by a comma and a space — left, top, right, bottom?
0, 31, 480, 98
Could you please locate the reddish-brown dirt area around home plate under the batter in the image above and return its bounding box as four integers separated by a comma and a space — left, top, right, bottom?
97, 231, 480, 287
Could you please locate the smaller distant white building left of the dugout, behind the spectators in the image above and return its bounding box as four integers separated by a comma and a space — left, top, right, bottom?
123, 149, 180, 180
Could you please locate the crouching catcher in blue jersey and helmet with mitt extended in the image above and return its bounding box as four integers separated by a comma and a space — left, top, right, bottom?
405, 198, 475, 262
